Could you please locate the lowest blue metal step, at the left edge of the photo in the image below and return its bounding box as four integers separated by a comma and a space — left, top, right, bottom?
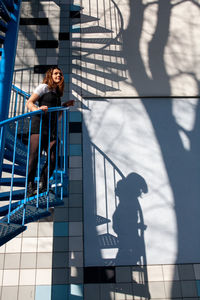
0, 221, 27, 246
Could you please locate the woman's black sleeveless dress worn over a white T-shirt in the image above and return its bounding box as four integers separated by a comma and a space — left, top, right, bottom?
31, 91, 61, 141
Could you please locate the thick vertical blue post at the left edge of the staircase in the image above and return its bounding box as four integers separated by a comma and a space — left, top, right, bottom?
0, 0, 21, 176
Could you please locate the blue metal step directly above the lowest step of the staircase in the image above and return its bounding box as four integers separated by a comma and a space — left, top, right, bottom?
1, 204, 51, 224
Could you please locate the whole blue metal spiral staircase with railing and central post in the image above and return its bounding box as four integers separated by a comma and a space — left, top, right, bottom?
0, 0, 68, 246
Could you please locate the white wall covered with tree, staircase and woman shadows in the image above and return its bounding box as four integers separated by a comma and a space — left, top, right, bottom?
81, 0, 200, 265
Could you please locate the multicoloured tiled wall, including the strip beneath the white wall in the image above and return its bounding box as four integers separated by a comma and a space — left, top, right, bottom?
0, 0, 200, 300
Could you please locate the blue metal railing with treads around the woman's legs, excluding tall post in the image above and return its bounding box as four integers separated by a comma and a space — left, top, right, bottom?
0, 107, 68, 245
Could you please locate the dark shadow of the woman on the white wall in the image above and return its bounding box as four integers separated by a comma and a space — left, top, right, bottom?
113, 173, 148, 266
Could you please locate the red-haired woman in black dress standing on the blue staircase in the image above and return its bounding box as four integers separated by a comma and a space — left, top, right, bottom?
26, 67, 74, 196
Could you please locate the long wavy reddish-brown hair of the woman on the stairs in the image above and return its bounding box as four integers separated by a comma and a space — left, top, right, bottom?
43, 67, 65, 97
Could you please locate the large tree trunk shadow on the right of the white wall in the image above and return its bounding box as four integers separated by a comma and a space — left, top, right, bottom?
122, 0, 200, 298
